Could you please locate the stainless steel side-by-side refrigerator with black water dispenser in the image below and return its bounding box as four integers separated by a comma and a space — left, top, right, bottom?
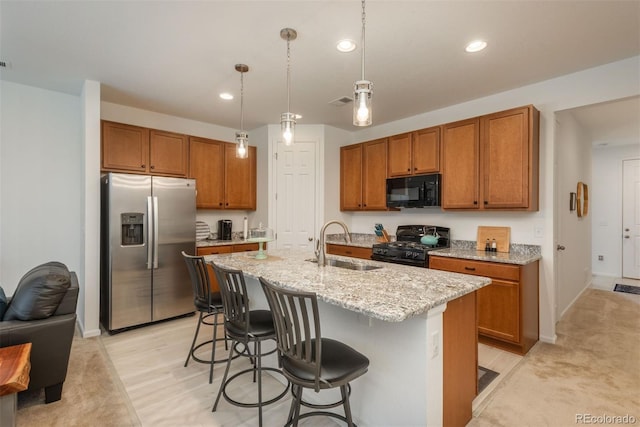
100, 173, 196, 332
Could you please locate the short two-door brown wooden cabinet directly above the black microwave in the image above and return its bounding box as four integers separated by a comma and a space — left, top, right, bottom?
387, 127, 440, 178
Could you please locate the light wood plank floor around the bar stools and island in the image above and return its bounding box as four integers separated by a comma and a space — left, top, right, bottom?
102, 276, 640, 427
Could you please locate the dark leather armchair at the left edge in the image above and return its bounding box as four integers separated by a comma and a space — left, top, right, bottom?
0, 262, 78, 403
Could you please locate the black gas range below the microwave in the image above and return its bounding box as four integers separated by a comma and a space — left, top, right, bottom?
371, 225, 450, 267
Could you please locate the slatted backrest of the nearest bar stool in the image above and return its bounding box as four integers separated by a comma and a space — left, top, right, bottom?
260, 277, 326, 391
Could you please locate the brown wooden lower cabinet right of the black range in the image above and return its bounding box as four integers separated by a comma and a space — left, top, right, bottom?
429, 256, 539, 355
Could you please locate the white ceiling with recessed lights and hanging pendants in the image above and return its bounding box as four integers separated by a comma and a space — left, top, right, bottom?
0, 0, 640, 131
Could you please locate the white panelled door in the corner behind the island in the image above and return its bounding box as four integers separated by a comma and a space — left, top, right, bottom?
275, 141, 316, 250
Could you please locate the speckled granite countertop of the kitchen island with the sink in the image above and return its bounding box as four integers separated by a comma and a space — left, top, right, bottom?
205, 249, 491, 322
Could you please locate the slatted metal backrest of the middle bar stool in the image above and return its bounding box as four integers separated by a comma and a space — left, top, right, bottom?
212, 263, 250, 340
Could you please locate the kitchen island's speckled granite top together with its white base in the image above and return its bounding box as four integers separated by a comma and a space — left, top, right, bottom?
205, 249, 491, 426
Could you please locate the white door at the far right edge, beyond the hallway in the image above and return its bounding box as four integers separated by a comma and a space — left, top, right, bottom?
622, 160, 640, 279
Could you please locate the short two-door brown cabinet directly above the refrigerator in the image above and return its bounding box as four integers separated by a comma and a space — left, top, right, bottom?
102, 121, 189, 177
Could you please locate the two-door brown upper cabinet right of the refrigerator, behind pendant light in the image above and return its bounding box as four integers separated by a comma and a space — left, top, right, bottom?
189, 136, 257, 210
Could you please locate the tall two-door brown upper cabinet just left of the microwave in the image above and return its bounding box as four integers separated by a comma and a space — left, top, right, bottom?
340, 138, 387, 211
